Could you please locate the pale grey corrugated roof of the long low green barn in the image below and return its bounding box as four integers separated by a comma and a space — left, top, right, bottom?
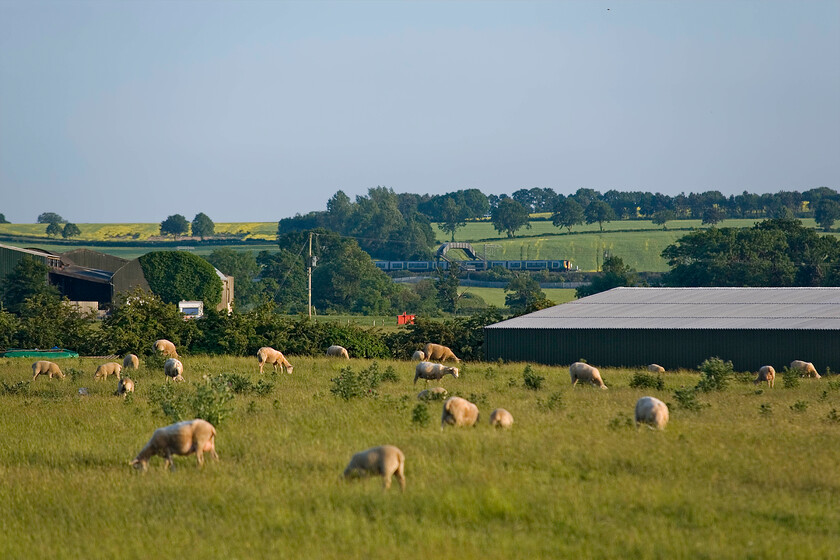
485, 288, 840, 330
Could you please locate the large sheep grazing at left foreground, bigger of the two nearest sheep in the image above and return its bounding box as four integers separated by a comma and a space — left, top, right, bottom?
129, 418, 219, 471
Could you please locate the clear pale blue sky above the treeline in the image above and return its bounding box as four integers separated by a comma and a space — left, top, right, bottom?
0, 0, 840, 223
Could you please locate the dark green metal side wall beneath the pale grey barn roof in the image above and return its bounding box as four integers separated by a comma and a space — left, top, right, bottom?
484, 329, 840, 372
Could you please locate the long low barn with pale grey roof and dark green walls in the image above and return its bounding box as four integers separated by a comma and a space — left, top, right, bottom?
484, 288, 840, 372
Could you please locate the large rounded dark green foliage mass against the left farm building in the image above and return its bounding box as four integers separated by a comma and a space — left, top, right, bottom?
140, 251, 222, 309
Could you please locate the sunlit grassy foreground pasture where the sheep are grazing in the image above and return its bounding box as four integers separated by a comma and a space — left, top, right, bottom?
0, 356, 840, 560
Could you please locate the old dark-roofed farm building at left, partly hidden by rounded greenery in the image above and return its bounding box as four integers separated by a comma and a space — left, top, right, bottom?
0, 245, 233, 311
